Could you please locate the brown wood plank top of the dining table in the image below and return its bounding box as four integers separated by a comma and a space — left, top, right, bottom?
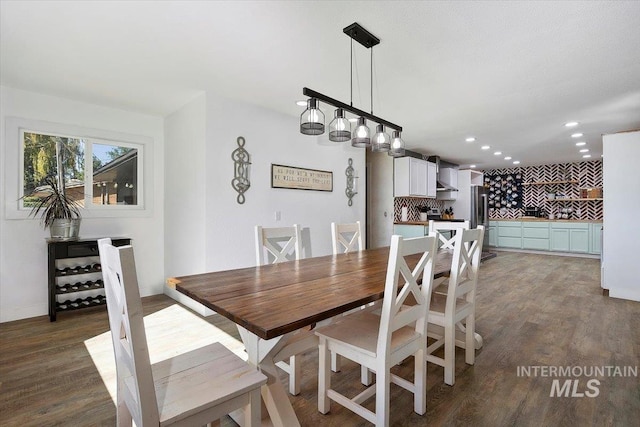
167, 247, 452, 339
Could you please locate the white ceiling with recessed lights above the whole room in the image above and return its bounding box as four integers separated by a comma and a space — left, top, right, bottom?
0, 0, 640, 169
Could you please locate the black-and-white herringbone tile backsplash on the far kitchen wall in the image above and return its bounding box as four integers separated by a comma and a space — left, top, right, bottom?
483, 160, 603, 221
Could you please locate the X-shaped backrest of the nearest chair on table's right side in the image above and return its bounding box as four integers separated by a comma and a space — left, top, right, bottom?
376, 233, 437, 357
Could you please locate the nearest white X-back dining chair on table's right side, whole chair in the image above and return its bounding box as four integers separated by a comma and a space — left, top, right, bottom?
316, 235, 436, 426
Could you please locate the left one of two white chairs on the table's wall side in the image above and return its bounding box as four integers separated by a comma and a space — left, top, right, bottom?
255, 224, 318, 396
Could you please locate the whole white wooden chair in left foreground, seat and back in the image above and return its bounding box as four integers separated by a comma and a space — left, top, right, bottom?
98, 239, 267, 427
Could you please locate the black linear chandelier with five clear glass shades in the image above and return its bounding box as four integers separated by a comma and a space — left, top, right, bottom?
300, 22, 404, 157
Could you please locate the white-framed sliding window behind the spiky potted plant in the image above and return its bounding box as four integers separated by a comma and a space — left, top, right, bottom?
0, 117, 154, 219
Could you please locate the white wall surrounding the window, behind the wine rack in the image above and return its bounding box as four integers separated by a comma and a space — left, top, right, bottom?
0, 87, 165, 322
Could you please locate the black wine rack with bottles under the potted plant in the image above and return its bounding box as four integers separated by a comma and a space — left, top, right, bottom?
47, 238, 131, 322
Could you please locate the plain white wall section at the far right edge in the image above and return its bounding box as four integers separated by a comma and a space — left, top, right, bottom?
602, 131, 640, 301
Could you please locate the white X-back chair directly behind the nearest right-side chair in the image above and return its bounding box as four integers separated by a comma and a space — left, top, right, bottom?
426, 226, 484, 385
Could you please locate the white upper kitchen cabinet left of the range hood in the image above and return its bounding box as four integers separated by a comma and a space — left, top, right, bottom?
393, 157, 436, 197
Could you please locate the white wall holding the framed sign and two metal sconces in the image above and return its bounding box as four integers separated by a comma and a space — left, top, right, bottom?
204, 94, 365, 271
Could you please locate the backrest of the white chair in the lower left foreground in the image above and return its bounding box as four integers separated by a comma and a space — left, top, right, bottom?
98, 239, 159, 426
